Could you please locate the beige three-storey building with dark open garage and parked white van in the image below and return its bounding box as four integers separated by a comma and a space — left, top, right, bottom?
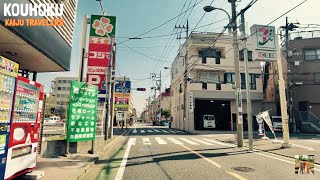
171, 33, 263, 131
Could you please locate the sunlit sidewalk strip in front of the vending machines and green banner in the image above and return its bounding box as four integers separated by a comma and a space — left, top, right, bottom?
18, 128, 130, 180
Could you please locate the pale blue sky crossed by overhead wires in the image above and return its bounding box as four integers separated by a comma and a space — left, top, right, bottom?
38, 0, 320, 112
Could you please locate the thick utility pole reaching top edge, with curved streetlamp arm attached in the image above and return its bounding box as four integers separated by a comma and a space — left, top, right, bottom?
228, 0, 243, 147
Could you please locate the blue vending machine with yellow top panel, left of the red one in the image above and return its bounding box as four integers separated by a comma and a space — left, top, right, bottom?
0, 56, 19, 179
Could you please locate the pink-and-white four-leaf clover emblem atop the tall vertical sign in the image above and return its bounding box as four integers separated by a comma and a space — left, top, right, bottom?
92, 17, 113, 36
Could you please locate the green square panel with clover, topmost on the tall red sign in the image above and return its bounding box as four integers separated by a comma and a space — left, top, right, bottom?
90, 15, 116, 37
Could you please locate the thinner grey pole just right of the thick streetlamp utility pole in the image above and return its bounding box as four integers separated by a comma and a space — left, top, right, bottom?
240, 9, 253, 151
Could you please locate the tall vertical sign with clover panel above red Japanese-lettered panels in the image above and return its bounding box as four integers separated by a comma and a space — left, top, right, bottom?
87, 15, 116, 100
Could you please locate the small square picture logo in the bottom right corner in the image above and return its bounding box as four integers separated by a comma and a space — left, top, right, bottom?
295, 155, 314, 174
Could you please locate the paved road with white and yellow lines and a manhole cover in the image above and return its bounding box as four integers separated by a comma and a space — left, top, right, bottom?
97, 124, 320, 180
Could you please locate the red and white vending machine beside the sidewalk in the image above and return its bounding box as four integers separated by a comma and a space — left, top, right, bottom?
5, 76, 44, 179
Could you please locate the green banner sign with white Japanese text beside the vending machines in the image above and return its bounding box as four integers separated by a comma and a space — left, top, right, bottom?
67, 81, 98, 142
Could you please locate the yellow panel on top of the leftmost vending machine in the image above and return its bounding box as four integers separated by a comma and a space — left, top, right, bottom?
0, 56, 19, 78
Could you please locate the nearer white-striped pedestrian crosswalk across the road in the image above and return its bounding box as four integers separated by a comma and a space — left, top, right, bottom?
128, 137, 236, 147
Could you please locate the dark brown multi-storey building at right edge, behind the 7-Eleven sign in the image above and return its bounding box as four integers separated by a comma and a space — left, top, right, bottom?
263, 33, 320, 132
